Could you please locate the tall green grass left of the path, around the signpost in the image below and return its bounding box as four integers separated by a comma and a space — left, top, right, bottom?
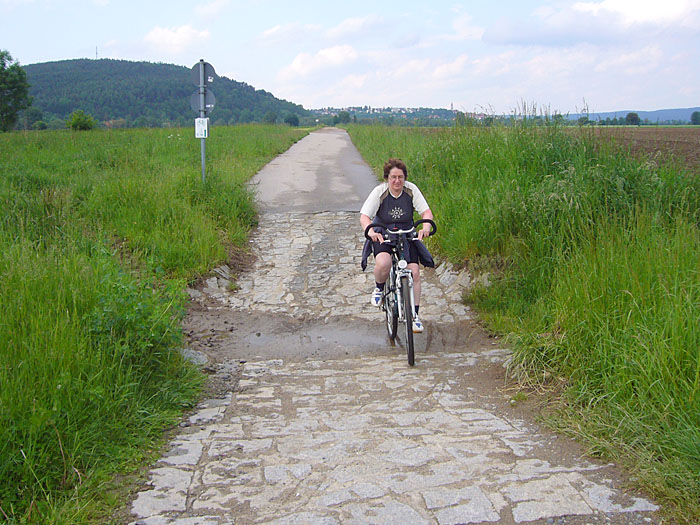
0, 125, 306, 523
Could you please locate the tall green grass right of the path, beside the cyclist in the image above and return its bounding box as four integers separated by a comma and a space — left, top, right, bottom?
349, 119, 700, 523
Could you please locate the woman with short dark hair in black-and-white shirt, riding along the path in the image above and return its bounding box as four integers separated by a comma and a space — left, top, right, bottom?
360, 158, 433, 333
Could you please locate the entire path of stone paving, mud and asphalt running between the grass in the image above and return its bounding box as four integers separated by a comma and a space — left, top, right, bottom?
131, 128, 660, 525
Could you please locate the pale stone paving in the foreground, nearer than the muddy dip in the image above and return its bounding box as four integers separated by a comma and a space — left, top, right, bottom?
133, 349, 656, 525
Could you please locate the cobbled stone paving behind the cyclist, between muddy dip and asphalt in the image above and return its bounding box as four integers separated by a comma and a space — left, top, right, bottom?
190, 212, 471, 323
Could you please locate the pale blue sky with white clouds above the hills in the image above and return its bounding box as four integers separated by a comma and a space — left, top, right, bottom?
0, 0, 700, 114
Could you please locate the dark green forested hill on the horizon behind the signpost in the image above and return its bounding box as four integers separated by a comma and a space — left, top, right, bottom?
23, 59, 309, 126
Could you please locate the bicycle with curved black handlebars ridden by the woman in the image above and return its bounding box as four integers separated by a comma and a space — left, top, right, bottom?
365, 219, 437, 366
